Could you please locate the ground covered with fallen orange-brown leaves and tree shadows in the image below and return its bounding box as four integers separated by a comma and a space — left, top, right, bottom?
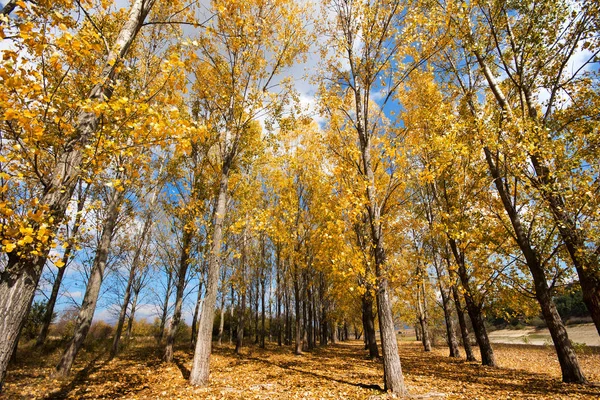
0, 340, 600, 399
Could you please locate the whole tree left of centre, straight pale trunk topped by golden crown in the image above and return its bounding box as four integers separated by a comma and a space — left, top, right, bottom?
190, 0, 306, 385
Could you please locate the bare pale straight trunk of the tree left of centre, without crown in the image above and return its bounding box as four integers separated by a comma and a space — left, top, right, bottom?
190, 168, 232, 385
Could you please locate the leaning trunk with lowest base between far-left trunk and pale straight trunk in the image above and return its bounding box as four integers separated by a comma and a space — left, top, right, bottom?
54, 189, 124, 377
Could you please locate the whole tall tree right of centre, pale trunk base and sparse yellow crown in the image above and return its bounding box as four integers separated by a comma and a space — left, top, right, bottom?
322, 1, 426, 395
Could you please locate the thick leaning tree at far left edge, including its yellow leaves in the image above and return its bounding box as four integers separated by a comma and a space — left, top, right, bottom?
0, 0, 155, 384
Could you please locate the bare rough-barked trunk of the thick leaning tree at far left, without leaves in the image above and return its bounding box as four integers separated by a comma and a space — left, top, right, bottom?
0, 0, 156, 390
